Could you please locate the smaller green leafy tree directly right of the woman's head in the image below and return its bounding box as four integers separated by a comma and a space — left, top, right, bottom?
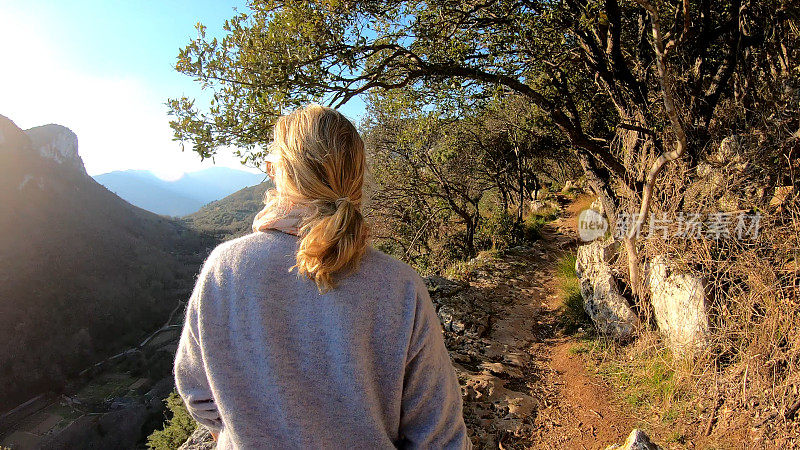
365, 98, 495, 259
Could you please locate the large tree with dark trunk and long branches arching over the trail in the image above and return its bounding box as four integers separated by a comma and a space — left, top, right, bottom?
170, 0, 796, 298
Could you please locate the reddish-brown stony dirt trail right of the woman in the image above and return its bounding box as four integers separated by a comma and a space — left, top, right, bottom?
432, 223, 636, 449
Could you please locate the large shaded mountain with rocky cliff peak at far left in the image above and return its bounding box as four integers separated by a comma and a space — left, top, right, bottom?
0, 116, 213, 413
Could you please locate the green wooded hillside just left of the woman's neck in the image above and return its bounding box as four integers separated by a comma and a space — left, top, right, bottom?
182, 181, 274, 241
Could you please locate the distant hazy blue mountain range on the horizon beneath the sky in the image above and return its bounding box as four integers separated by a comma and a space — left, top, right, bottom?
94, 167, 264, 216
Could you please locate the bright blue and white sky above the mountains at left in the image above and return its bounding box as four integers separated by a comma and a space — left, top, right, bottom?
0, 0, 364, 179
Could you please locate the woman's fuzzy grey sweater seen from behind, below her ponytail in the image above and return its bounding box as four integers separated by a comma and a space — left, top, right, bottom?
175, 231, 471, 448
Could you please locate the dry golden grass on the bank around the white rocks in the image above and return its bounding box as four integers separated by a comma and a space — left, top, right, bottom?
601, 136, 800, 442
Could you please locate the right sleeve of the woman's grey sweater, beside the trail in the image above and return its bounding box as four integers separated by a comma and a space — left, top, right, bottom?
400, 279, 472, 449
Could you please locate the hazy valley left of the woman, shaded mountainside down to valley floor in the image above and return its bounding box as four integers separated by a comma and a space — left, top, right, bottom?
0, 116, 222, 448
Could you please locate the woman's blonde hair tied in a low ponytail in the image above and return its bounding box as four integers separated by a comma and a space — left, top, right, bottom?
271, 103, 368, 293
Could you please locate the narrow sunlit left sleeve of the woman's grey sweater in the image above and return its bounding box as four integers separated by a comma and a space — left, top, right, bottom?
174, 253, 223, 435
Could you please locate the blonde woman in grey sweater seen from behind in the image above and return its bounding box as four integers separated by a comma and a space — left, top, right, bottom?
175, 104, 471, 448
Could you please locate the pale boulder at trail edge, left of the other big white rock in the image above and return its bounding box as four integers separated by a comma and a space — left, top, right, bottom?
575, 240, 639, 342
